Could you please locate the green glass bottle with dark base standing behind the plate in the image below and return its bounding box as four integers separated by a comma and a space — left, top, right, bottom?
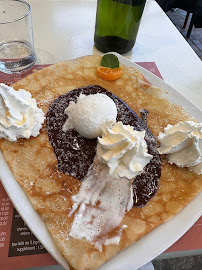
94, 0, 146, 54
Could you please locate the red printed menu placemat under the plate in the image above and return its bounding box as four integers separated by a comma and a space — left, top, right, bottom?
0, 62, 202, 270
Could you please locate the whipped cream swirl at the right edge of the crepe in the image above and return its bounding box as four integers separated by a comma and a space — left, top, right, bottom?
158, 121, 202, 174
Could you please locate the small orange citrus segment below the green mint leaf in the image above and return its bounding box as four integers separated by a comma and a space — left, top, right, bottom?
97, 66, 123, 81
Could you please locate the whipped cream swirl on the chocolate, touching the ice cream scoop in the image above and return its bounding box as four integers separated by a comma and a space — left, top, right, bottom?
97, 122, 153, 179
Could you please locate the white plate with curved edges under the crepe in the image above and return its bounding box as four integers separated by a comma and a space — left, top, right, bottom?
0, 53, 202, 270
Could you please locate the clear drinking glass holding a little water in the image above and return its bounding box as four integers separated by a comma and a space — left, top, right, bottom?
0, 0, 36, 74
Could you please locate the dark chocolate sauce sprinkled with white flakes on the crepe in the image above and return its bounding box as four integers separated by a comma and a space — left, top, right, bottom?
46, 85, 161, 207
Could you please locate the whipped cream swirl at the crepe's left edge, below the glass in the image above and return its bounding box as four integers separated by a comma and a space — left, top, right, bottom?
0, 83, 45, 141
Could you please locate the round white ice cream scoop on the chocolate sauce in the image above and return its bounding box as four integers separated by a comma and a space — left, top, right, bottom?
63, 94, 117, 139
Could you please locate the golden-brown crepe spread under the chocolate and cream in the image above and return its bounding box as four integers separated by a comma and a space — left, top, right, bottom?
0, 56, 202, 270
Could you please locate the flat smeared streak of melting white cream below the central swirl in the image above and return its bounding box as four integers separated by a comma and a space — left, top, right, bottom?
69, 158, 133, 251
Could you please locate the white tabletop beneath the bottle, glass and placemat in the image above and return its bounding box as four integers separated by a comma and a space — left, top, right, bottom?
9, 0, 202, 270
